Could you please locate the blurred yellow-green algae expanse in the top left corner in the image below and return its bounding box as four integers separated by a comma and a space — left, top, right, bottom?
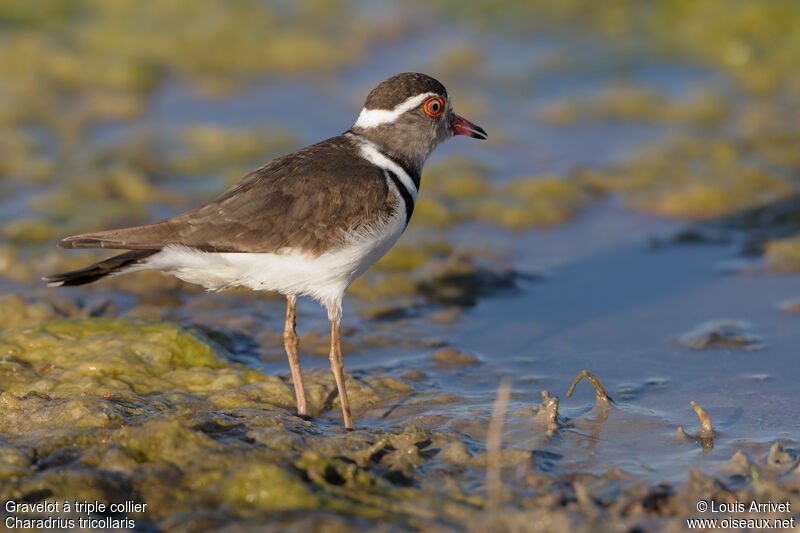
0, 0, 369, 139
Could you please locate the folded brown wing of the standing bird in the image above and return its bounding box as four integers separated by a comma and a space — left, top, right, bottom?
59, 136, 393, 255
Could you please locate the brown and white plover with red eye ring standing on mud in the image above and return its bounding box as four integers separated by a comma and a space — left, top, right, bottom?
42, 72, 487, 430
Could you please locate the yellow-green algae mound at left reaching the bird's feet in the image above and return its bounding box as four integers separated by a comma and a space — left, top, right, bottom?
0, 316, 424, 426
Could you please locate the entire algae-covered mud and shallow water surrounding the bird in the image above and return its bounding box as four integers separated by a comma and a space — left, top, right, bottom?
0, 0, 800, 531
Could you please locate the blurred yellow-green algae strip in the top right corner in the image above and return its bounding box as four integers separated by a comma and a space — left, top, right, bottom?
432, 0, 800, 98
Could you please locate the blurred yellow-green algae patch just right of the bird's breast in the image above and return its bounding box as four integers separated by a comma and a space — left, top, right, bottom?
348, 162, 580, 316
